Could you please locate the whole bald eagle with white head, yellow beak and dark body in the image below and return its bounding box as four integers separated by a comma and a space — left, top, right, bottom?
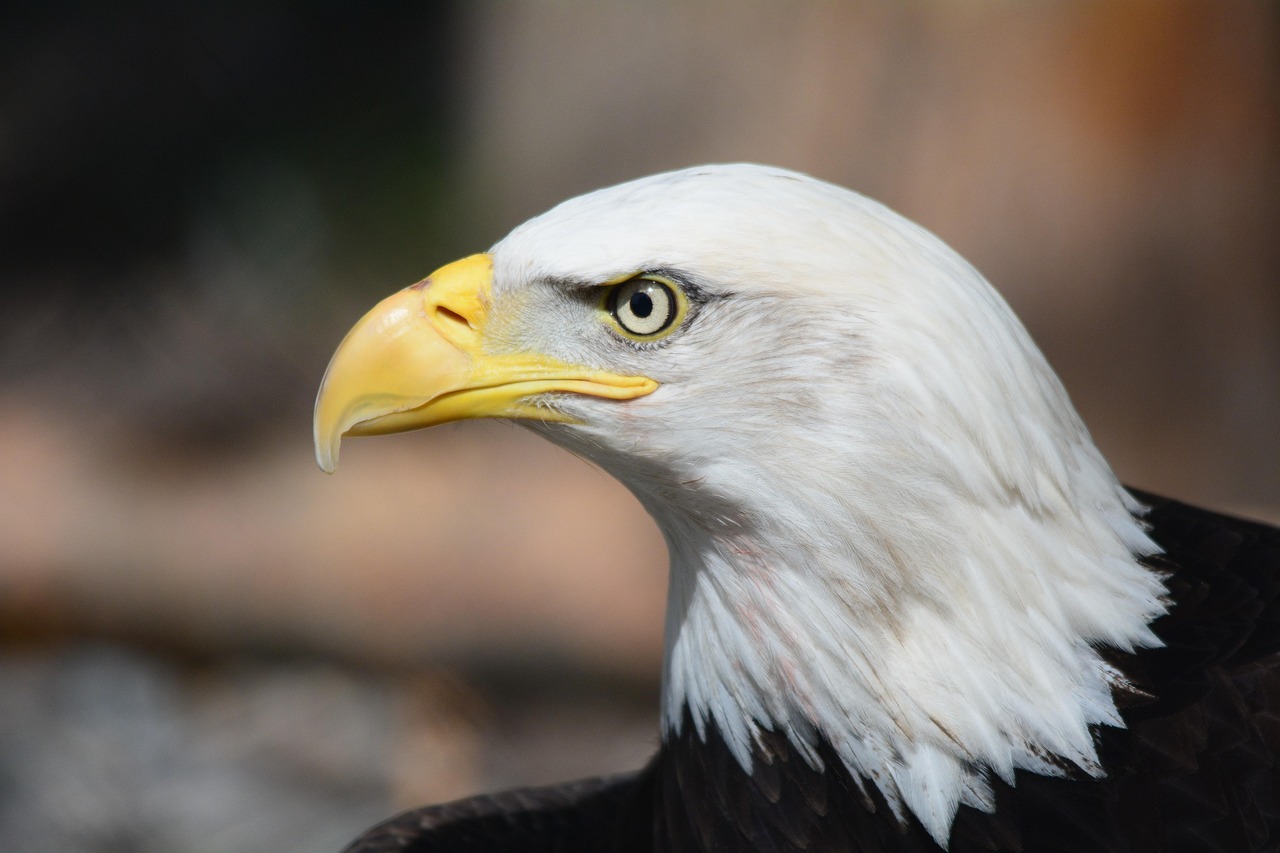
315, 165, 1280, 853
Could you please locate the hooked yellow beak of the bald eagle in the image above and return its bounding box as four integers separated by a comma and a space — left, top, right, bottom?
315, 255, 658, 474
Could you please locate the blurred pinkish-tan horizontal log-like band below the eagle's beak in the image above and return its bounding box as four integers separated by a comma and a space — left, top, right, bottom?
0, 406, 666, 680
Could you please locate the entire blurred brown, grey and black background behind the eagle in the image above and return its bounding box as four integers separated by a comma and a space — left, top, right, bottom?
0, 0, 1280, 852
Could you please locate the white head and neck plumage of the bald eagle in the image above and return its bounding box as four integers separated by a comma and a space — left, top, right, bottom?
483, 165, 1165, 845
